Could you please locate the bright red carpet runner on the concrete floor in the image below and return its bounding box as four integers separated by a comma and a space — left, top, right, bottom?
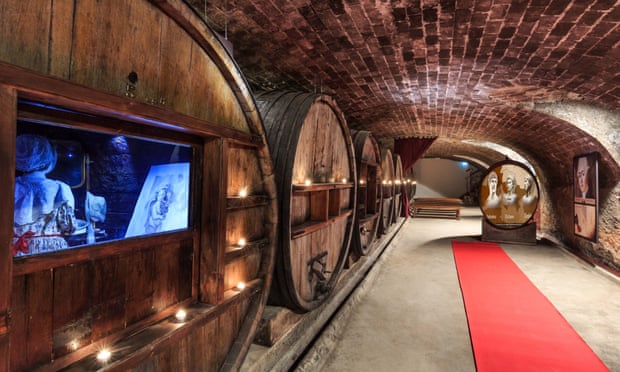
452, 241, 609, 372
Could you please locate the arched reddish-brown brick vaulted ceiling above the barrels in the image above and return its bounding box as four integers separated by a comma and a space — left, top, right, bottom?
188, 0, 620, 184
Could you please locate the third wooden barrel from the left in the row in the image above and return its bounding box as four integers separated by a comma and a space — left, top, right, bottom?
351, 130, 383, 257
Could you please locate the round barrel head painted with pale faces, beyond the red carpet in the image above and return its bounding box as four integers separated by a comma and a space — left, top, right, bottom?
480, 160, 539, 229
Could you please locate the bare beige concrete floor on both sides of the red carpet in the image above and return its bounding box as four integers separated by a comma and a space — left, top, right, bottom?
318, 208, 620, 372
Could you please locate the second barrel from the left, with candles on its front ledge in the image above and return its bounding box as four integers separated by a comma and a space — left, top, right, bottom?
255, 91, 357, 312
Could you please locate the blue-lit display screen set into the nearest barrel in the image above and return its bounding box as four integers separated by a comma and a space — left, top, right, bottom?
13, 120, 193, 257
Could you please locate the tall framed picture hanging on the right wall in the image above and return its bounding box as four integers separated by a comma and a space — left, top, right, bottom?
573, 153, 598, 242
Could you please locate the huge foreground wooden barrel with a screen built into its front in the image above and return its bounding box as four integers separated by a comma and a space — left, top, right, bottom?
0, 0, 277, 371
